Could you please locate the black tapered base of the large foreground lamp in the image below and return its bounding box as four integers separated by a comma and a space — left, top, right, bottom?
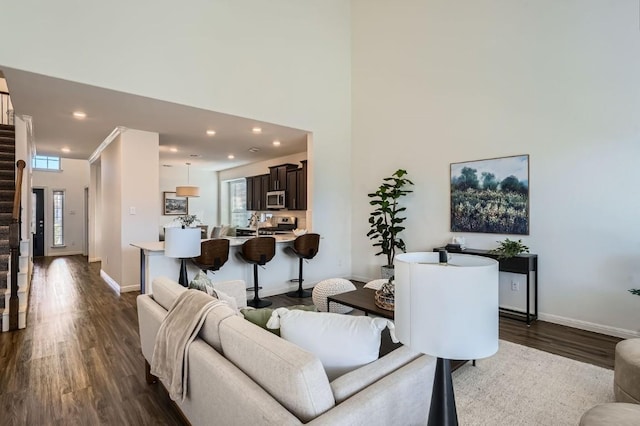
427, 358, 458, 426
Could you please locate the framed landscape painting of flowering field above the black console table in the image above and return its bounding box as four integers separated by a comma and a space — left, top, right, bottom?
451, 155, 529, 235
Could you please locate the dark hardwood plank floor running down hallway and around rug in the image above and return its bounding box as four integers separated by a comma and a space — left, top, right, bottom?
0, 256, 620, 425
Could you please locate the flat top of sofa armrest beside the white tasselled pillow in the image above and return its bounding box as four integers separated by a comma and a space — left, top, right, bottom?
331, 346, 421, 404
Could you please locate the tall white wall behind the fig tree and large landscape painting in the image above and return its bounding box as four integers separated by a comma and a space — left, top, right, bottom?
351, 0, 640, 335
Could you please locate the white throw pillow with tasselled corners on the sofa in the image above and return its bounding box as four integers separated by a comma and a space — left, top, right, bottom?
267, 308, 398, 381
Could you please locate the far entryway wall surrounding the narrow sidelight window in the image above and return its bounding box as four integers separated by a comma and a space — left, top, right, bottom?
32, 158, 89, 256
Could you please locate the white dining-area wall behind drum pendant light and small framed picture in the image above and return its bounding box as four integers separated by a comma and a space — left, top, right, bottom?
157, 165, 218, 232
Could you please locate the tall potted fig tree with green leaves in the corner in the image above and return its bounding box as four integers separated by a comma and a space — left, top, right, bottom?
367, 169, 413, 278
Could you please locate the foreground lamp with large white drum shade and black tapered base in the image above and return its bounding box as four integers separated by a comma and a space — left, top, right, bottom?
394, 252, 498, 426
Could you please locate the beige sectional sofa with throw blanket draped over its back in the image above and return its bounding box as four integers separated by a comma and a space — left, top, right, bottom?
138, 278, 435, 425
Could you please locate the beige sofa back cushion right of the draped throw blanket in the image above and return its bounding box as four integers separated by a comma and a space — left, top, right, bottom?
220, 311, 335, 423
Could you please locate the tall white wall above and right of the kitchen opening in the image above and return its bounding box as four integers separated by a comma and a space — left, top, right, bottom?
0, 0, 351, 277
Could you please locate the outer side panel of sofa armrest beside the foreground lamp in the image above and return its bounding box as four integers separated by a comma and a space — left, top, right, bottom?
308, 355, 436, 426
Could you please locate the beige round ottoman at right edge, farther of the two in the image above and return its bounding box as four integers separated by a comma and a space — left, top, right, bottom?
613, 339, 640, 404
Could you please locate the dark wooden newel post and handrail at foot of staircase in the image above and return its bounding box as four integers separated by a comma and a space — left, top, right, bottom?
9, 160, 26, 330
